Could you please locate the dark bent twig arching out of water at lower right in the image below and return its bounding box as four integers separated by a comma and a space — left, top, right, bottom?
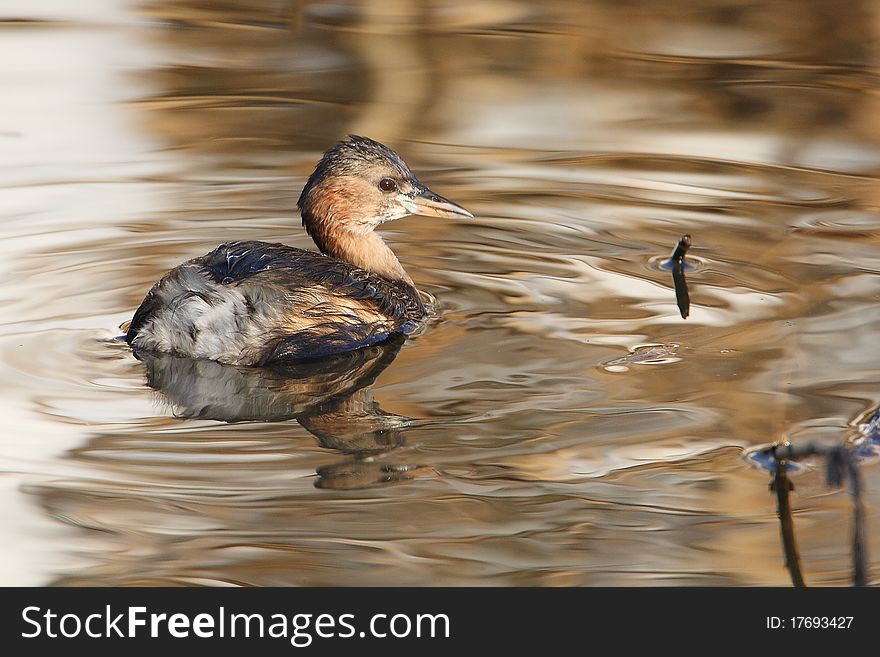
766, 442, 868, 586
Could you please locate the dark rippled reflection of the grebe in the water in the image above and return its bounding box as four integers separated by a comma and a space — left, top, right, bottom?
136, 335, 427, 489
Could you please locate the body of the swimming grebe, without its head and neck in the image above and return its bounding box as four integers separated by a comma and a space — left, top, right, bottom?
126, 242, 426, 365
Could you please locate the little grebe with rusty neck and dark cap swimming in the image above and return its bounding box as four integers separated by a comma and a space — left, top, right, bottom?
125, 135, 473, 365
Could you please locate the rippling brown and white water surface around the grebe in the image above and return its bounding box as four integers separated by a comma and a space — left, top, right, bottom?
0, 0, 880, 586
